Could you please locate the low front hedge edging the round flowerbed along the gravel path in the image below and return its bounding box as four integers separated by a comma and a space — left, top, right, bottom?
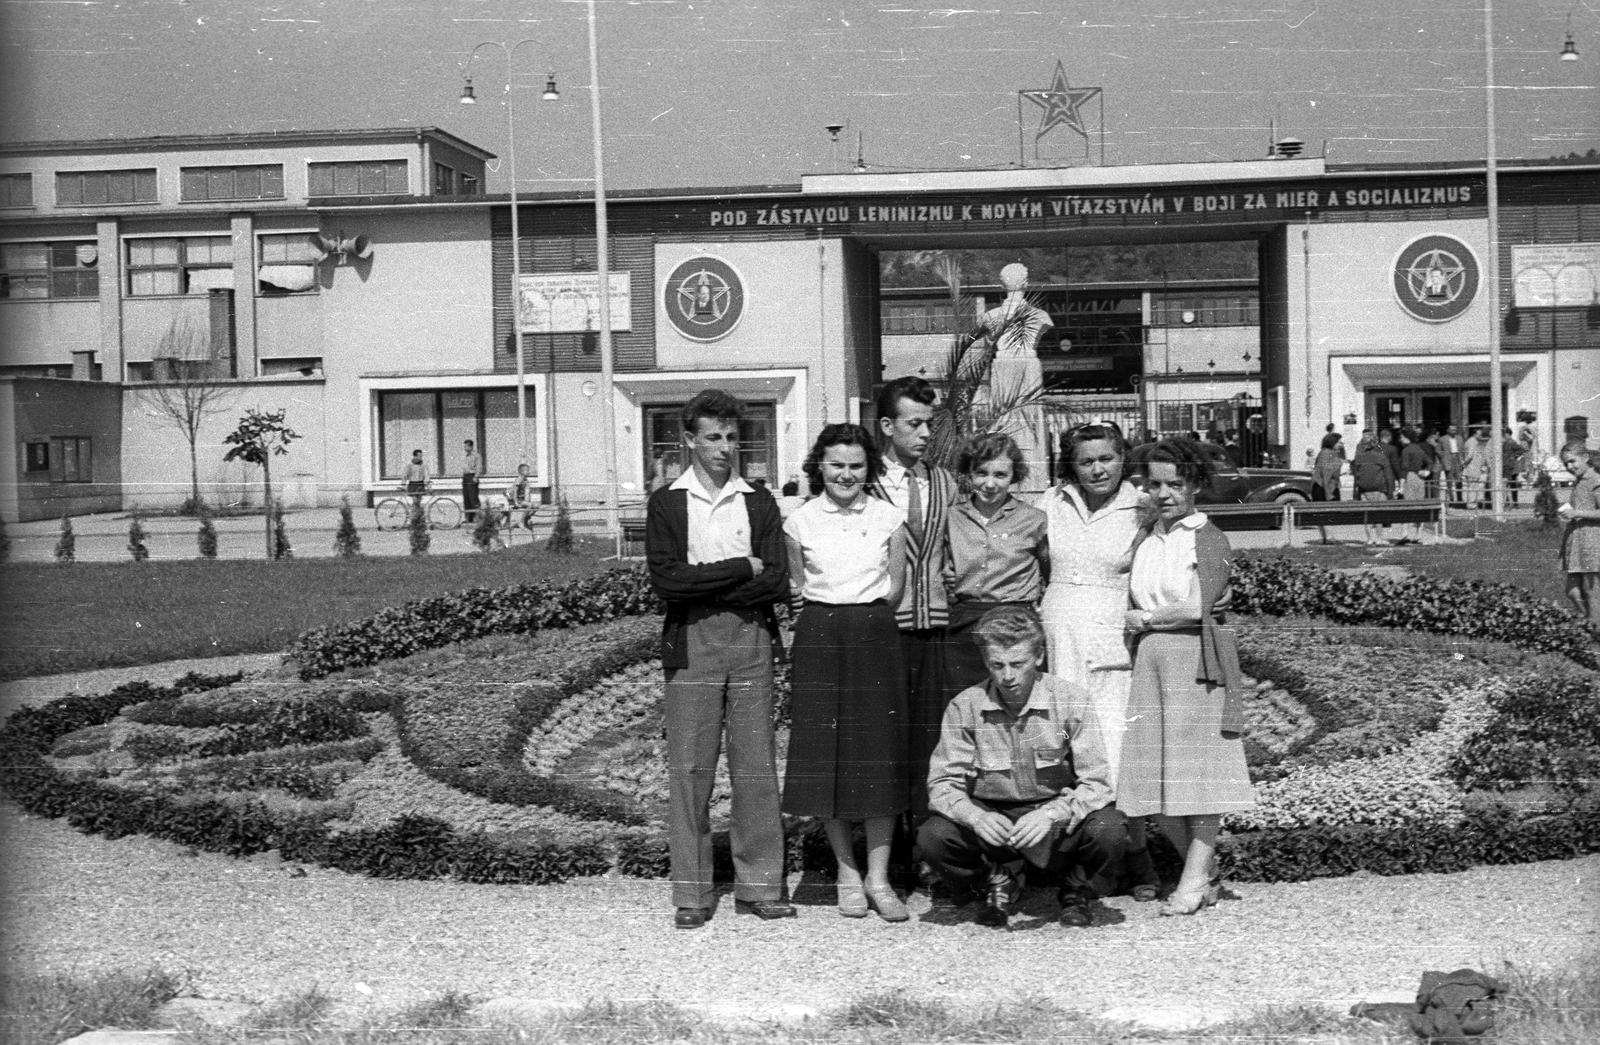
0, 687, 1600, 883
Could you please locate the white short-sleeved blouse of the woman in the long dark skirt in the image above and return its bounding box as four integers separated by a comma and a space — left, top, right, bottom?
784, 493, 906, 607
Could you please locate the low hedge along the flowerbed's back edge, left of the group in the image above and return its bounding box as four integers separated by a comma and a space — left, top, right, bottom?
286, 567, 661, 679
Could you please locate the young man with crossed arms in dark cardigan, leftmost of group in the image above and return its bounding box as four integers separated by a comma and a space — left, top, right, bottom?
645, 389, 795, 930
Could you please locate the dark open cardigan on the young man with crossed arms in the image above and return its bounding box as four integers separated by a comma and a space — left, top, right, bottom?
645, 486, 789, 667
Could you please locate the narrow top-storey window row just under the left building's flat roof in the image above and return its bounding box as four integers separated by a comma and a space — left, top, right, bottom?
0, 160, 425, 208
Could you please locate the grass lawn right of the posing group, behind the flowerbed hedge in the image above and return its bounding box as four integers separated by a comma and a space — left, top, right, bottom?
1240, 520, 1573, 610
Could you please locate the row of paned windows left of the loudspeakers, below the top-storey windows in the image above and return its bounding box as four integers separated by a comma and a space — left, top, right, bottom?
0, 232, 320, 298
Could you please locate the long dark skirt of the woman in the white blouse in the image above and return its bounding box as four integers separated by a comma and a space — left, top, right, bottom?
782, 602, 910, 819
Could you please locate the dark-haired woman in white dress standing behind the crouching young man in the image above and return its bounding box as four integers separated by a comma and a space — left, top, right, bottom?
1038, 424, 1160, 901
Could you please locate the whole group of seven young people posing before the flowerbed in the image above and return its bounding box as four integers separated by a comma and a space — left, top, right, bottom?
646, 378, 1254, 928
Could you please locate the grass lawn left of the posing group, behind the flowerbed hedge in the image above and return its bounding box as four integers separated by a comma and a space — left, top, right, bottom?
0, 544, 614, 680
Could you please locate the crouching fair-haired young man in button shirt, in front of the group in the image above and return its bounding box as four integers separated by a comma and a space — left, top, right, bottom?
917, 607, 1128, 927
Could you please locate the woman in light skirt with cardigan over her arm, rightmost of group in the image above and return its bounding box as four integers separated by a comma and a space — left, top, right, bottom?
1117, 438, 1256, 914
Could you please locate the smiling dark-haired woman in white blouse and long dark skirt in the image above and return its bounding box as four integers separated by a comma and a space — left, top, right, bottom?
782, 424, 912, 922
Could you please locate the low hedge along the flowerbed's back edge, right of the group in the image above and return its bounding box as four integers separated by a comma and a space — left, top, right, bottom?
1234, 559, 1600, 669
